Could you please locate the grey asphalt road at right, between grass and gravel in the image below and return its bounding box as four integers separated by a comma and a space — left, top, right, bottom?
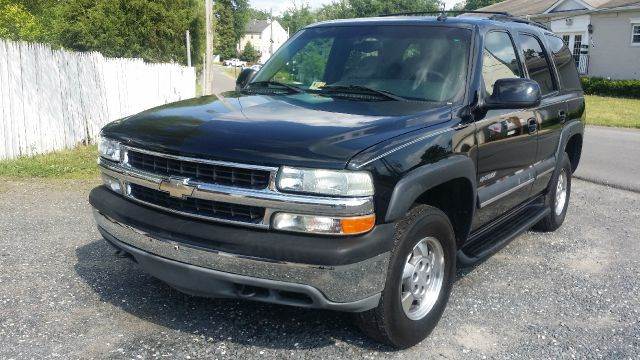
575, 126, 640, 192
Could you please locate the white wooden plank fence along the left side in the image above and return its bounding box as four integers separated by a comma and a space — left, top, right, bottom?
0, 39, 196, 159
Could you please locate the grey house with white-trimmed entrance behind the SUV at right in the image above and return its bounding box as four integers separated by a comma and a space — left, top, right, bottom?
478, 0, 640, 79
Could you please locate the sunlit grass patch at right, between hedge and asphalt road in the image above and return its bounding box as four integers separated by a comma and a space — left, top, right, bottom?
586, 95, 640, 129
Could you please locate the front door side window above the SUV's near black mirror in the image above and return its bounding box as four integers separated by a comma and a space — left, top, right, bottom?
482, 32, 522, 95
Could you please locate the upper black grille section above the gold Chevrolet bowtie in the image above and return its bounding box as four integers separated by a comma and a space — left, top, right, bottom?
127, 150, 270, 189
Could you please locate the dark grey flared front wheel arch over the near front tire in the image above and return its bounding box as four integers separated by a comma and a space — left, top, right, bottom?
385, 155, 476, 245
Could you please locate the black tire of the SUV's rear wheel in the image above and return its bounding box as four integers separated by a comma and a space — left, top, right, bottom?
533, 153, 572, 232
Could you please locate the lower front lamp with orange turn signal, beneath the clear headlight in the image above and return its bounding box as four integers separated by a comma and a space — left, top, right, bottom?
272, 213, 376, 235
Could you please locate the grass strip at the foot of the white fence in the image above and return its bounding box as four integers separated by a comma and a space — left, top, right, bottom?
0, 146, 99, 180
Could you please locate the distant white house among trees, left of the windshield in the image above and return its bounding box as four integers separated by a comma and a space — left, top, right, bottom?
238, 20, 289, 64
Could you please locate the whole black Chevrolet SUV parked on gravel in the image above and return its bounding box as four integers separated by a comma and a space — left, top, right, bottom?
90, 14, 585, 348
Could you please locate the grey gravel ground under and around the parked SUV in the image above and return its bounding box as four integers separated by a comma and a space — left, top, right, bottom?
0, 180, 640, 359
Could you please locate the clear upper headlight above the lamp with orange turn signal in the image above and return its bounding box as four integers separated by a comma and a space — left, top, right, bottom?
278, 167, 373, 196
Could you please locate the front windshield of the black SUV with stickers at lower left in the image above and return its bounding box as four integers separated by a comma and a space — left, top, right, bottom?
252, 25, 471, 102
